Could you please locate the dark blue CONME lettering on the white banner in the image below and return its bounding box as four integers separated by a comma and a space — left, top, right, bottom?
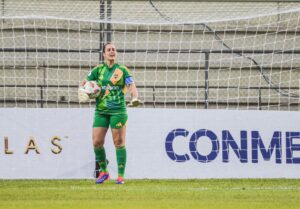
165, 128, 300, 164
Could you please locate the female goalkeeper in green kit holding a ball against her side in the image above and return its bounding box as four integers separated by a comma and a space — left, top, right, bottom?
79, 43, 141, 184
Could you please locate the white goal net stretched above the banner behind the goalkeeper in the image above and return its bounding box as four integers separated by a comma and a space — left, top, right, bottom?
0, 0, 300, 110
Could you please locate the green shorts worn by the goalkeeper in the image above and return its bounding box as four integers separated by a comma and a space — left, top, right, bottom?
93, 111, 128, 129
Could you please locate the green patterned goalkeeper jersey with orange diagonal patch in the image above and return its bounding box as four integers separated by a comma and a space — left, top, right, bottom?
87, 63, 133, 114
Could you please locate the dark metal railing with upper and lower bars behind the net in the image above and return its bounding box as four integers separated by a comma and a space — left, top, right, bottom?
0, 48, 300, 109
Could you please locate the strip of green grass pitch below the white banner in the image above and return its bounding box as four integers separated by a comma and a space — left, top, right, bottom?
0, 179, 300, 209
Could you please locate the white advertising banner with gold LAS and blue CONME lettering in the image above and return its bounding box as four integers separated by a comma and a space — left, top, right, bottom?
0, 109, 300, 179
